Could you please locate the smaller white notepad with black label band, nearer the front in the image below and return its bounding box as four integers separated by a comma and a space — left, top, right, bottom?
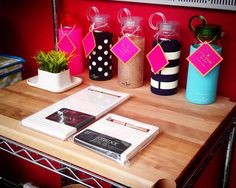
74, 114, 159, 164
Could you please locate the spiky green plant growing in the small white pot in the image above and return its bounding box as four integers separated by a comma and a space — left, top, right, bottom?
35, 50, 70, 73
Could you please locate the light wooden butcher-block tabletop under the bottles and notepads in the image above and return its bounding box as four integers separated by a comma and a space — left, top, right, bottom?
0, 73, 235, 188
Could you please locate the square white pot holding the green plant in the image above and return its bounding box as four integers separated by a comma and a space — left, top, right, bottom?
38, 69, 71, 90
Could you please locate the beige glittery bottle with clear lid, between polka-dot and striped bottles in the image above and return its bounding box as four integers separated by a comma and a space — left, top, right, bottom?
118, 16, 145, 88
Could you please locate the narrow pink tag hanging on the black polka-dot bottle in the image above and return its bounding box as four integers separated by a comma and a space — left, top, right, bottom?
82, 31, 96, 57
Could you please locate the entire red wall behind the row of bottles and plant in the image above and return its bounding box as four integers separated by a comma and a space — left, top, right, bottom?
0, 0, 236, 187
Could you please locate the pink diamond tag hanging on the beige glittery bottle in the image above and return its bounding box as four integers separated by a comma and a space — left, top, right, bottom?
111, 36, 140, 63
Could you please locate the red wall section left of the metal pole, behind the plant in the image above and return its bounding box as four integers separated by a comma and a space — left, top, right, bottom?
0, 0, 53, 78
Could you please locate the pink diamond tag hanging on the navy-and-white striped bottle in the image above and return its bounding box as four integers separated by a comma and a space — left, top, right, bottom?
146, 44, 169, 74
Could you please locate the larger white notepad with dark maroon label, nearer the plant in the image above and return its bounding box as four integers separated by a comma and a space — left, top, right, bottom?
21, 86, 130, 140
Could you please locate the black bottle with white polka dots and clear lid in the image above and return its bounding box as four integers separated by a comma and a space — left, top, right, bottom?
88, 14, 113, 81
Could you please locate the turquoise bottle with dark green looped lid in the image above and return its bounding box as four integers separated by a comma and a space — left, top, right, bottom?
186, 16, 222, 104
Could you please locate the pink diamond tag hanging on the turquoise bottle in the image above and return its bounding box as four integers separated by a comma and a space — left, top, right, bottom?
187, 42, 223, 76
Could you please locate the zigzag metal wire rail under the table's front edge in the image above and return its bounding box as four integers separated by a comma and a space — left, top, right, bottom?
0, 136, 126, 188
